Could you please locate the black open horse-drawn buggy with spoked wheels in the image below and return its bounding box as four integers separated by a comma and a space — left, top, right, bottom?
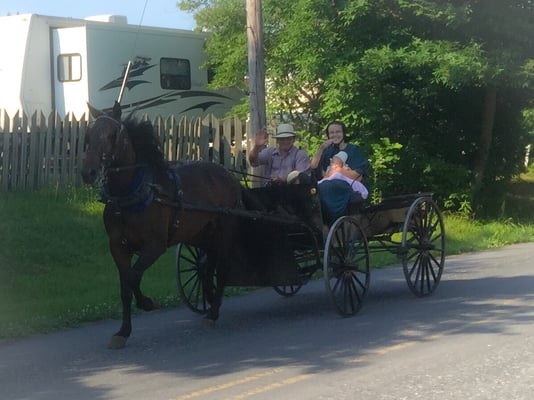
176, 184, 445, 316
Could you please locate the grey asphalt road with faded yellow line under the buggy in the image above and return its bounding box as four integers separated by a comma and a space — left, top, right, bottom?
0, 243, 534, 400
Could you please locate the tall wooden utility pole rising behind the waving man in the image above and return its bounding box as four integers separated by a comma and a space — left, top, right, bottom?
247, 0, 267, 147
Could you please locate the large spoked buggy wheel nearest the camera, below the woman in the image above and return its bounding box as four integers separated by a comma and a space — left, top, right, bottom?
323, 216, 371, 317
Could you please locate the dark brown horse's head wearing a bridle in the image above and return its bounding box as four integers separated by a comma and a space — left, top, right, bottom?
81, 103, 122, 184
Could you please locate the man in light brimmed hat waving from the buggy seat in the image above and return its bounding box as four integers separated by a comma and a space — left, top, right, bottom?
248, 124, 311, 184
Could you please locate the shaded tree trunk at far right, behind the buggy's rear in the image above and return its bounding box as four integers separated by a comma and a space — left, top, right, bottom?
471, 87, 497, 199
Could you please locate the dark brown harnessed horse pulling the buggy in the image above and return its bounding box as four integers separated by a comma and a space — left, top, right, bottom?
82, 106, 242, 348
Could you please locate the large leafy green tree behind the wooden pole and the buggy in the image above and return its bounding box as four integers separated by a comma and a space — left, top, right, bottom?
180, 0, 534, 216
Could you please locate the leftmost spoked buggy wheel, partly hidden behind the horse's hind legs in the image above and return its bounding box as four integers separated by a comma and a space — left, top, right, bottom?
176, 243, 216, 314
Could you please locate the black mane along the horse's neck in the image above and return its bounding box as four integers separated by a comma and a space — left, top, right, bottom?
123, 118, 168, 172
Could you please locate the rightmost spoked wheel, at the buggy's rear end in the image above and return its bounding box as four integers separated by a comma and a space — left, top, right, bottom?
401, 197, 445, 297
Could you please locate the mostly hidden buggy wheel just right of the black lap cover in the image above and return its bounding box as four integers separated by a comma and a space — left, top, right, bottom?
273, 227, 321, 297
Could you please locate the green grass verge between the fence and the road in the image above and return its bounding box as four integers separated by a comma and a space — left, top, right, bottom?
0, 175, 534, 339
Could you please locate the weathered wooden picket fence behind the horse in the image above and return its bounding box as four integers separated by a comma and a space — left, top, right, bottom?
0, 110, 249, 191
